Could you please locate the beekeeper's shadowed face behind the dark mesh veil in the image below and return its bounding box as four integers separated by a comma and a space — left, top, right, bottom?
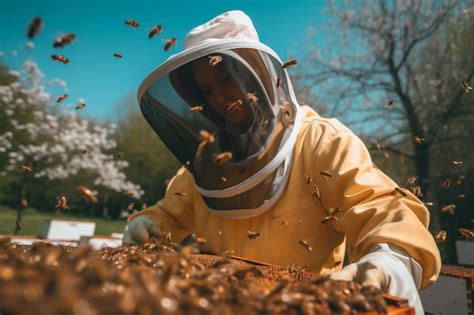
192, 57, 250, 124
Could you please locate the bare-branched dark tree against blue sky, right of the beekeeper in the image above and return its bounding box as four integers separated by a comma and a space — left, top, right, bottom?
294, 0, 474, 209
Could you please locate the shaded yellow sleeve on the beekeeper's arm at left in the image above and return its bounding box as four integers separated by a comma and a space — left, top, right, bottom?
128, 167, 195, 242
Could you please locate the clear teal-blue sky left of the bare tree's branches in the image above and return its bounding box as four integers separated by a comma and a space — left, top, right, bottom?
0, 0, 326, 120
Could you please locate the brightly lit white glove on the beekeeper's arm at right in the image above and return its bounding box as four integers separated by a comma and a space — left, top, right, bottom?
330, 243, 424, 315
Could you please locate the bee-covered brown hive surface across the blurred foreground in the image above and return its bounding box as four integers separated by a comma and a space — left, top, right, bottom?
0, 239, 413, 315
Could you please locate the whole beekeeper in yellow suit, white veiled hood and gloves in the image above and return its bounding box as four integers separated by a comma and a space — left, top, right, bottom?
124, 11, 440, 314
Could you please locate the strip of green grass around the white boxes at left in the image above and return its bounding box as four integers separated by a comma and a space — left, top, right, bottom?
0, 205, 126, 236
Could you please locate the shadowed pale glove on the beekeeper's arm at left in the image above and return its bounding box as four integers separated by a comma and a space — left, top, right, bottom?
122, 215, 163, 244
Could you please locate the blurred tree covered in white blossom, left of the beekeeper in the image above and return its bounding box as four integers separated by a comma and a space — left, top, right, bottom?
0, 61, 144, 198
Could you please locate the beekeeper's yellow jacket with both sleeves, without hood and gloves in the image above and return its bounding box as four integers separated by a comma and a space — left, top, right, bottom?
129, 106, 441, 289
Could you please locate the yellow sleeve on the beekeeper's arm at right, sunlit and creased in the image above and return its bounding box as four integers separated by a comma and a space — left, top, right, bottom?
312, 124, 441, 289
